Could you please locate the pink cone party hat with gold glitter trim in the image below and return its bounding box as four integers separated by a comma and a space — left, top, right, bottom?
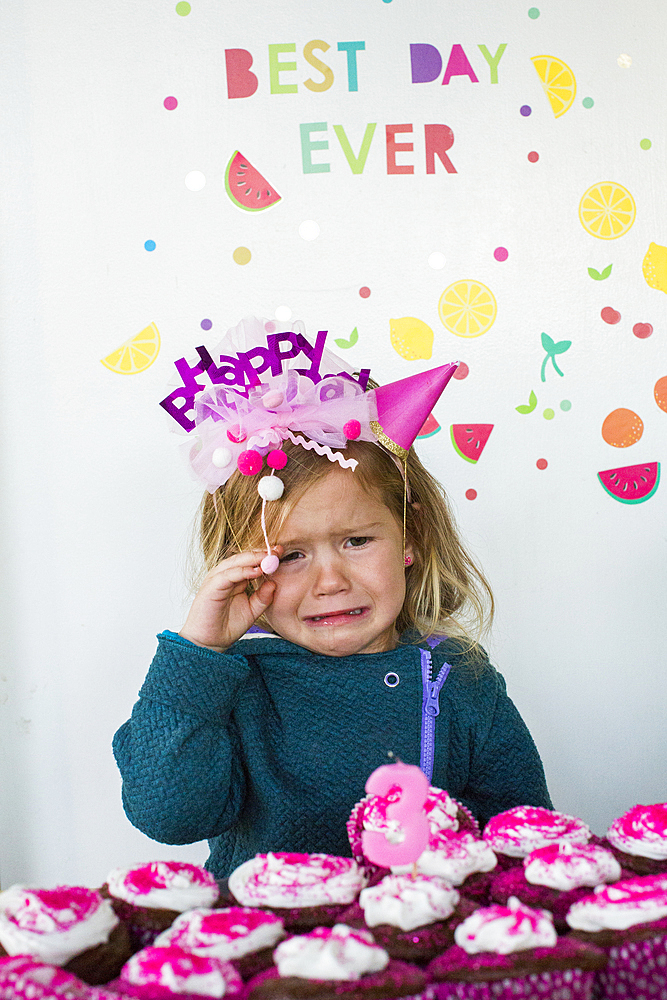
371, 361, 459, 458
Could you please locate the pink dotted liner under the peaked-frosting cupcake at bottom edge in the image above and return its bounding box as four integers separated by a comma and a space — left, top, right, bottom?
432, 969, 595, 1000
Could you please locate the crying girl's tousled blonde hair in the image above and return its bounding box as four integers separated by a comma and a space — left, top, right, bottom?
194, 441, 493, 647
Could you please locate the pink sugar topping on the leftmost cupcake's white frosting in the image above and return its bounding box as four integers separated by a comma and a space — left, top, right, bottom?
0, 885, 104, 934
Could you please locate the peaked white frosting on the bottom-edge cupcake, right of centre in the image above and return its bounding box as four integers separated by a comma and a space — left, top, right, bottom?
454, 896, 558, 955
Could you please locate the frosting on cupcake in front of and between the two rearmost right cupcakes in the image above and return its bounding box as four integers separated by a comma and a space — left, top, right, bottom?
523, 841, 621, 892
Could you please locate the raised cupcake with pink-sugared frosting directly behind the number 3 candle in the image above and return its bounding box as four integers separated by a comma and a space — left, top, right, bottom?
347, 786, 480, 877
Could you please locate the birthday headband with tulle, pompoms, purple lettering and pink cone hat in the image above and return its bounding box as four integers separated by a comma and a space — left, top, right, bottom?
160, 317, 458, 573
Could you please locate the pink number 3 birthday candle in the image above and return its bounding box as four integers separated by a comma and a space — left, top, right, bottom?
361, 763, 429, 868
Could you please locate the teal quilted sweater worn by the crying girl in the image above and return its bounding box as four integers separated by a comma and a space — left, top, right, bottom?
114, 632, 552, 878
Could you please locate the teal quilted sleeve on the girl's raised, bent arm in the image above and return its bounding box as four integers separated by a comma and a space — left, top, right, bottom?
113, 632, 250, 844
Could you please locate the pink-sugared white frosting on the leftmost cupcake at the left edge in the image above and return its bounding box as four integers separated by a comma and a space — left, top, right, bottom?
0, 885, 119, 965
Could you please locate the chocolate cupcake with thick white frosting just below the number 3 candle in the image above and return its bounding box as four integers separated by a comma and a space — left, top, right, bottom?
342, 875, 475, 962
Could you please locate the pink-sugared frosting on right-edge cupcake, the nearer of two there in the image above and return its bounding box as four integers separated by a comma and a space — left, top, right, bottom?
565, 875, 667, 932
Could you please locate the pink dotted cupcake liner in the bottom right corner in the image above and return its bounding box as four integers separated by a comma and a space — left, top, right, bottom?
594, 935, 667, 1000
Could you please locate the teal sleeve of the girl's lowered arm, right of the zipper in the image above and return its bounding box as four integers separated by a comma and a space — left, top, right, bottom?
456, 664, 553, 827
